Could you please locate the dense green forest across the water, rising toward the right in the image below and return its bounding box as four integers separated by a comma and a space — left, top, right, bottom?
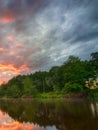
0, 52, 98, 98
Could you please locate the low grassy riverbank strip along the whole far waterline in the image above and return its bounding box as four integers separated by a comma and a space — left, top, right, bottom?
1, 90, 98, 100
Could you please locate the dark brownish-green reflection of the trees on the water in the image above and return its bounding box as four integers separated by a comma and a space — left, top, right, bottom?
0, 100, 98, 130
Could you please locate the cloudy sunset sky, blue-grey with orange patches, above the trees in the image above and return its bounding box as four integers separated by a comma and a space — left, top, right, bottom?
0, 0, 98, 83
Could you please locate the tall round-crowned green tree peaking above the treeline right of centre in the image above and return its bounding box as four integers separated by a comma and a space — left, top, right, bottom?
59, 56, 88, 86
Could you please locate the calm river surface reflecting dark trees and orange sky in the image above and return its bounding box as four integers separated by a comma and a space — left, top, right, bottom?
0, 100, 98, 130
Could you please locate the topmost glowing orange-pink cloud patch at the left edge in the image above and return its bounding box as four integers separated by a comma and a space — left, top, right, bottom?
0, 11, 15, 23
